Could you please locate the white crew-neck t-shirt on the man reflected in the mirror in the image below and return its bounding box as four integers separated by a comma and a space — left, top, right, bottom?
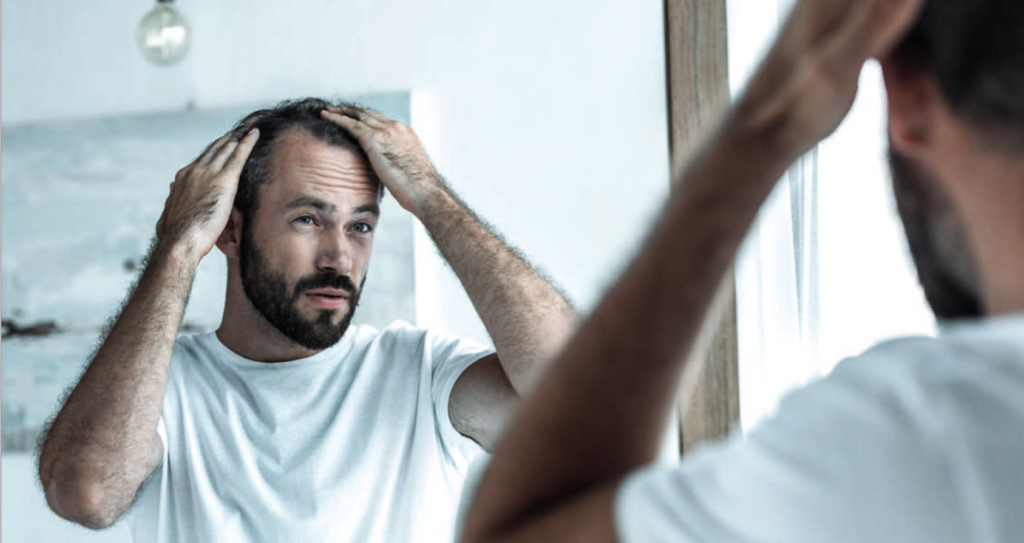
130, 323, 493, 543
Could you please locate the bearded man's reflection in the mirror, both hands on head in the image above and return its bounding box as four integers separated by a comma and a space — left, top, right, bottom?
39, 99, 573, 542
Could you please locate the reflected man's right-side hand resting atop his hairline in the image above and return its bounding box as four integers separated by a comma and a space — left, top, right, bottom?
322, 106, 444, 215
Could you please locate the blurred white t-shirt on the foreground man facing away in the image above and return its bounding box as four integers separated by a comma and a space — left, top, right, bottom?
614, 315, 1024, 543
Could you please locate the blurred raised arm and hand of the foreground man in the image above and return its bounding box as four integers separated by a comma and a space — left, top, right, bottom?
463, 0, 921, 543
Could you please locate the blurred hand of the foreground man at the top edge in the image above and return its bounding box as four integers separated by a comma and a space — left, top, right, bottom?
731, 0, 925, 160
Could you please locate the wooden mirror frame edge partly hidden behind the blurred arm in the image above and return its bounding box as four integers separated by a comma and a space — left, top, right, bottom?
665, 0, 739, 453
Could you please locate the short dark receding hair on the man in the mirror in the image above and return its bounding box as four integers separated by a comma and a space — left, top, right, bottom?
232, 98, 384, 223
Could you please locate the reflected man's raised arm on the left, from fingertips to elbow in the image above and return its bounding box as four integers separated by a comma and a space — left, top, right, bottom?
39, 132, 258, 529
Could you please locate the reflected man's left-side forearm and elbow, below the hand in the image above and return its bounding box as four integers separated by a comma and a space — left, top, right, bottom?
39, 238, 196, 528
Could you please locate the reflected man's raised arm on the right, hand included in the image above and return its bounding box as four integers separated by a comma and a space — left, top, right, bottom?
325, 108, 575, 449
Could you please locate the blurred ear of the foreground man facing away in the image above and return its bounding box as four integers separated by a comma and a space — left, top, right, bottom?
881, 57, 940, 156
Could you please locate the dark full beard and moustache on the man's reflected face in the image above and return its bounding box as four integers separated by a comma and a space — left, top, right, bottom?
239, 223, 367, 350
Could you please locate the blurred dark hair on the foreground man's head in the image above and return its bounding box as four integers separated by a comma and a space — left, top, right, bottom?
895, 0, 1024, 147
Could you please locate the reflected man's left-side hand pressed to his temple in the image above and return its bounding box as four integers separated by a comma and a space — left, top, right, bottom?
157, 128, 259, 264
